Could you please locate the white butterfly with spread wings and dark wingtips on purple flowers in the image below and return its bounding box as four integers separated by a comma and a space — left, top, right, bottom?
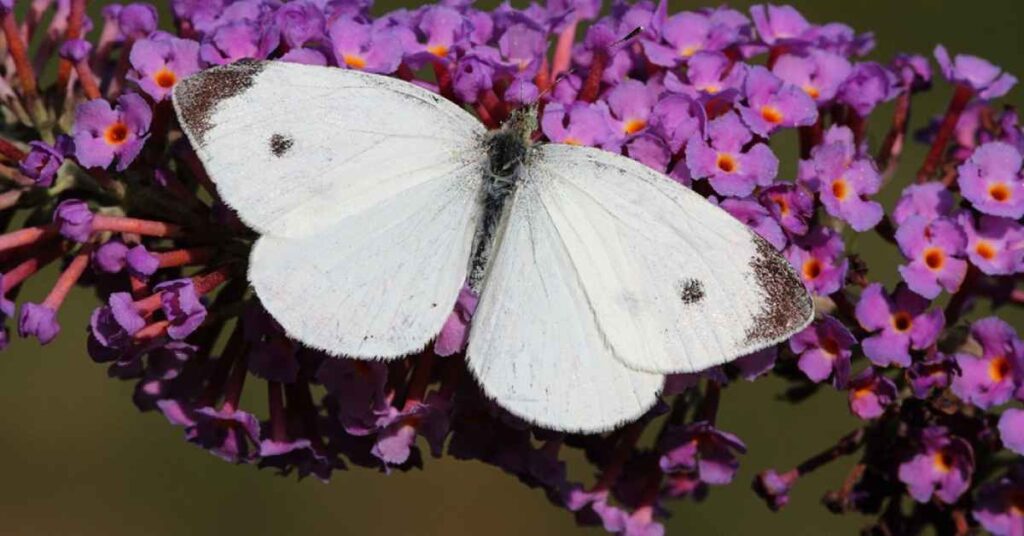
174, 61, 813, 431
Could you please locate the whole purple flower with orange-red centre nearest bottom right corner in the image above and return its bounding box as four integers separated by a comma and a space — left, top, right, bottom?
899, 426, 974, 504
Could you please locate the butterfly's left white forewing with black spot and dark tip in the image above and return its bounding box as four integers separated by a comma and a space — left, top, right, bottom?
174, 61, 484, 237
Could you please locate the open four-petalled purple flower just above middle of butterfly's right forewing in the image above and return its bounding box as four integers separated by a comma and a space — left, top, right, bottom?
686, 112, 778, 197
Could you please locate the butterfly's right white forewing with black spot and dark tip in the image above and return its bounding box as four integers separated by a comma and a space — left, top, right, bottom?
529, 145, 813, 373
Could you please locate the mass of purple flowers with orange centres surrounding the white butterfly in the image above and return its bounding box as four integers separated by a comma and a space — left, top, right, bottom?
0, 0, 1024, 535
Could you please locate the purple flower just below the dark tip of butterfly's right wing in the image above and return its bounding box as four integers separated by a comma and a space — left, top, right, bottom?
790, 315, 857, 388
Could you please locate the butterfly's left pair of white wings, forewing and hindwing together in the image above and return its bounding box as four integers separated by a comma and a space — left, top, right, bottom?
174, 61, 483, 358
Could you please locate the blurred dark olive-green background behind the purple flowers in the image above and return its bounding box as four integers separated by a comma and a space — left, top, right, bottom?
0, 0, 1024, 536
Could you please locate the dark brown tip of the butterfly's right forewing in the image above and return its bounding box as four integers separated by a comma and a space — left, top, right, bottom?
744, 233, 814, 344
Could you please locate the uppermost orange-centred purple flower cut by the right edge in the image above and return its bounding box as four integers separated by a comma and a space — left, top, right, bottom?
956, 141, 1024, 219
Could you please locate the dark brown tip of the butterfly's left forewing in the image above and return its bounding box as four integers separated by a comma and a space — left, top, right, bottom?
174, 59, 266, 146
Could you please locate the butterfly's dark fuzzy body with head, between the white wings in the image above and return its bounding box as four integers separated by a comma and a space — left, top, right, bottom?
469, 107, 537, 291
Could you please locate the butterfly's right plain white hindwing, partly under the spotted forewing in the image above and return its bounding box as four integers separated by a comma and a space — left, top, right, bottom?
466, 177, 663, 432
